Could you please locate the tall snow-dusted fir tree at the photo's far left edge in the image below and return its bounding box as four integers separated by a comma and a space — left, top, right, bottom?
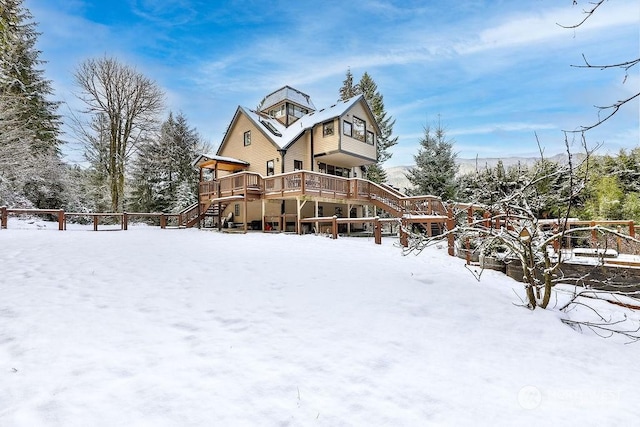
0, 0, 68, 208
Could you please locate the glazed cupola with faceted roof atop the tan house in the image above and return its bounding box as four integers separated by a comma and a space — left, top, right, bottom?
260, 86, 316, 126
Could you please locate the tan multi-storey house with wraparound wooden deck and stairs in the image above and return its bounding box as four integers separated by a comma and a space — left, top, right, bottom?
187, 86, 444, 232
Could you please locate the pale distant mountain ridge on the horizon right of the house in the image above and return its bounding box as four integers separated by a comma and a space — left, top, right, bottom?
385, 154, 567, 192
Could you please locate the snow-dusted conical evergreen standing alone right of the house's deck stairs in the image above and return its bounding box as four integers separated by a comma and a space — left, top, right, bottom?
406, 123, 458, 200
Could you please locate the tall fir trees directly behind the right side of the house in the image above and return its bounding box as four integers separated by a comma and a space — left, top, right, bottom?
340, 70, 398, 183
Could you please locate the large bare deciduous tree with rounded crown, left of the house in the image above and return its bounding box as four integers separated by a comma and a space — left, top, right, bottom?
74, 57, 164, 212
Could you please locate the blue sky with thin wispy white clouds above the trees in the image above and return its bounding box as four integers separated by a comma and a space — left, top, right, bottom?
24, 0, 640, 166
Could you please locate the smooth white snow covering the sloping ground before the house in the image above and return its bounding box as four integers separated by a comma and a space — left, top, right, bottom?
0, 219, 640, 427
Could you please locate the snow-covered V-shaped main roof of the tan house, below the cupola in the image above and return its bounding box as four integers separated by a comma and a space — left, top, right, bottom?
239, 95, 364, 148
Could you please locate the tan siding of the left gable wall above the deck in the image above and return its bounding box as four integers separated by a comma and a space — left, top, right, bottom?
219, 113, 280, 175
